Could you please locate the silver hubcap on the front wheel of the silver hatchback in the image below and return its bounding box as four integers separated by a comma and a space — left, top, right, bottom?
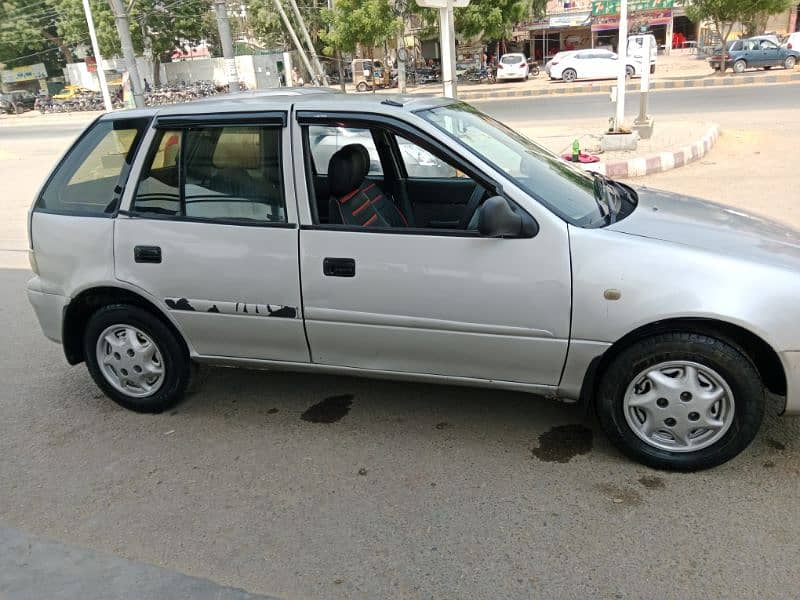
623, 361, 734, 452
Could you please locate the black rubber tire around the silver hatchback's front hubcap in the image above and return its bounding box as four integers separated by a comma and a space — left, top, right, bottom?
596, 332, 765, 471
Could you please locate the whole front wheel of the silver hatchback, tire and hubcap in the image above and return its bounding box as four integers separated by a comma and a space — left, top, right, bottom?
597, 332, 765, 471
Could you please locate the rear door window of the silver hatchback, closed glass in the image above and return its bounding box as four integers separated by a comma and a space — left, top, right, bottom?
132, 126, 286, 223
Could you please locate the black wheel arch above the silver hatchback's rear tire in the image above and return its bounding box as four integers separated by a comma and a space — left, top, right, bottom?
61, 285, 191, 365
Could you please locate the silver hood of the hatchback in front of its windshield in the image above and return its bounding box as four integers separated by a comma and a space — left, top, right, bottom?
609, 188, 800, 271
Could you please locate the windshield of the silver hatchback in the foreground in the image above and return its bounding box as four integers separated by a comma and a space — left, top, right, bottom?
417, 103, 635, 227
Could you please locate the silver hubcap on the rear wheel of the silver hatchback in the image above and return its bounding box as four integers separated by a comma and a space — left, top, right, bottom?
97, 325, 164, 398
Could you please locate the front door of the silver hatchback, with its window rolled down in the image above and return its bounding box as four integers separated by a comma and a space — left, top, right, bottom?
295, 114, 570, 385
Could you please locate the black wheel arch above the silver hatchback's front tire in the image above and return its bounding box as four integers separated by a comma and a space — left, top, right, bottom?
580, 317, 787, 407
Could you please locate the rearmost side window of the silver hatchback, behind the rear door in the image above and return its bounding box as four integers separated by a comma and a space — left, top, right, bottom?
36, 119, 149, 216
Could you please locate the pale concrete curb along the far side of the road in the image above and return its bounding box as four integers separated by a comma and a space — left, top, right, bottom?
458, 72, 800, 100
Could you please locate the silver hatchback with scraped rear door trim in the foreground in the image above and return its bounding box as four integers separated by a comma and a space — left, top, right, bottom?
28, 94, 800, 470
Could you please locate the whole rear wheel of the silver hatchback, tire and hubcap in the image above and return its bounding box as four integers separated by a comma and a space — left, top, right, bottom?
83, 304, 190, 413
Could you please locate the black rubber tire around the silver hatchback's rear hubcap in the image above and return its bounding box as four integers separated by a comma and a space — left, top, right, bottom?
83, 304, 191, 413
